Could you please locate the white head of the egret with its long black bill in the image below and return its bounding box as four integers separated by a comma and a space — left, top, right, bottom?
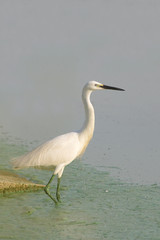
85, 81, 125, 91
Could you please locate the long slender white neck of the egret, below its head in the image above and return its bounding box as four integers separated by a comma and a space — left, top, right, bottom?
79, 88, 95, 143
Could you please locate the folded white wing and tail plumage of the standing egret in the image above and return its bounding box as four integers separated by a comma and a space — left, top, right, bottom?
13, 132, 80, 168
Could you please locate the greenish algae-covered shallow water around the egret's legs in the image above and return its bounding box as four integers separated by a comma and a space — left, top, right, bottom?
0, 139, 160, 240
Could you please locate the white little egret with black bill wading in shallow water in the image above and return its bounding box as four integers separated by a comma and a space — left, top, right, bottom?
13, 81, 124, 204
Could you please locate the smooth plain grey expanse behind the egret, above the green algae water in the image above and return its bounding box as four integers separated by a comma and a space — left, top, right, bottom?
0, 0, 160, 183
